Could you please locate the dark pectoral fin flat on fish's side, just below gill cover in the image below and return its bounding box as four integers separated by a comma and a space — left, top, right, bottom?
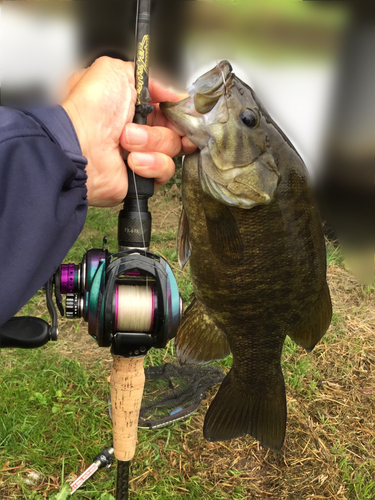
203, 195, 244, 264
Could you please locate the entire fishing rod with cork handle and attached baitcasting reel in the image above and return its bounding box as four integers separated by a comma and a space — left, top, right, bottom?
0, 0, 182, 500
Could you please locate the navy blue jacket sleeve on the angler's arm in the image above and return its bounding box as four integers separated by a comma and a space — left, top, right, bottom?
0, 106, 87, 326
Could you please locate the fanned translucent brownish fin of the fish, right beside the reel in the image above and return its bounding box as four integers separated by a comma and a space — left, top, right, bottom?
176, 298, 230, 364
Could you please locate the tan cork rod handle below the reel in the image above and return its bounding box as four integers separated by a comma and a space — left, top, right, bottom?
111, 356, 145, 461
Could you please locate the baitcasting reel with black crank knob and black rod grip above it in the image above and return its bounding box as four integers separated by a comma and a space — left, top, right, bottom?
0, 180, 182, 357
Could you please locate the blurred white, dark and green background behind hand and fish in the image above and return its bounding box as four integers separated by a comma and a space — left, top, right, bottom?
0, 0, 375, 282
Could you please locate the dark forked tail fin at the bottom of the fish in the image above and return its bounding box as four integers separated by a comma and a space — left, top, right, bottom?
203, 367, 287, 451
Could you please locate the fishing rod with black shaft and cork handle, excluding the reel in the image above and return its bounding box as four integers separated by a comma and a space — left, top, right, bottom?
111, 0, 162, 494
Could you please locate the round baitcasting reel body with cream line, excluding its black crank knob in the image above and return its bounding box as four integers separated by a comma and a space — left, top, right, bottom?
53, 241, 182, 357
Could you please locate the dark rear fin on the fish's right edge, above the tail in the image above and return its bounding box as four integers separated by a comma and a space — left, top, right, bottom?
288, 285, 332, 352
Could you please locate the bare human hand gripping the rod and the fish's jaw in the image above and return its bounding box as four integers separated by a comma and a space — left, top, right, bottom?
62, 57, 196, 207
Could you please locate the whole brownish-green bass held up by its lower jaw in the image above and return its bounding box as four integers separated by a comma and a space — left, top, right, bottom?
161, 61, 332, 451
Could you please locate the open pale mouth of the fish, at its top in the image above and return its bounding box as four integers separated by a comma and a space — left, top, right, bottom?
160, 61, 233, 114
